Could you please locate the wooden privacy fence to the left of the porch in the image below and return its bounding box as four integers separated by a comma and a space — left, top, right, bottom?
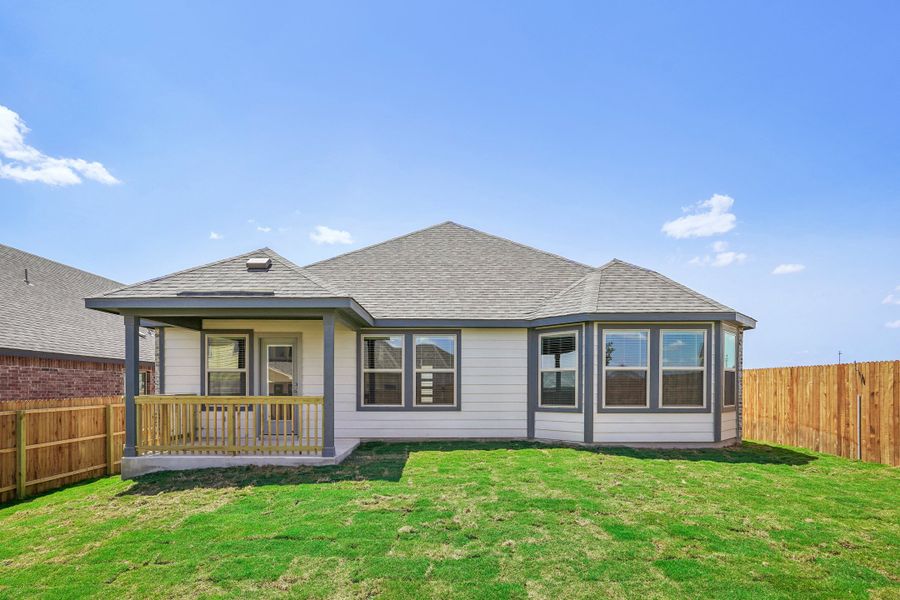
0, 396, 125, 502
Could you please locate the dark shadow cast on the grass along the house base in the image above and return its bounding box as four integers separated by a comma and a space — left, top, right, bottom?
119, 441, 816, 496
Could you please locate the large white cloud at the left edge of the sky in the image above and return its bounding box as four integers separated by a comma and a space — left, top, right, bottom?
0, 105, 120, 185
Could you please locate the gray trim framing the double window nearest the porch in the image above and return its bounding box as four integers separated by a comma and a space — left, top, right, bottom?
356, 328, 462, 412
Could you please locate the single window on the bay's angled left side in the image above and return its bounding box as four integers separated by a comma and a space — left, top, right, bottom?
538, 331, 578, 408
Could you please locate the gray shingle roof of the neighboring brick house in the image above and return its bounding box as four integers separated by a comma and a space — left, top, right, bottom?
0, 244, 155, 361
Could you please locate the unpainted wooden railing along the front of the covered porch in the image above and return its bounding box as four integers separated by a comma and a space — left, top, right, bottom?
135, 396, 324, 455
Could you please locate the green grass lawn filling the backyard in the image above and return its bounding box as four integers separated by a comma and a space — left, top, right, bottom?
0, 443, 900, 600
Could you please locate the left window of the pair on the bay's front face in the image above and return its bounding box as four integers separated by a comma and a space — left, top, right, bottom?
603, 330, 650, 407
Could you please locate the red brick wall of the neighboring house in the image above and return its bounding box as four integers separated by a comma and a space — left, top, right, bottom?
0, 356, 156, 400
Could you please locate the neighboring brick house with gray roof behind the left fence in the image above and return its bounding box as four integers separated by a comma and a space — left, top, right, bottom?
0, 244, 155, 400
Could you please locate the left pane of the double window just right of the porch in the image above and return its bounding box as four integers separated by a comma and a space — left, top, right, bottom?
362, 334, 403, 406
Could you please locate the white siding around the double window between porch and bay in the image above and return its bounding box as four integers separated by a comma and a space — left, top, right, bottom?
335, 327, 528, 439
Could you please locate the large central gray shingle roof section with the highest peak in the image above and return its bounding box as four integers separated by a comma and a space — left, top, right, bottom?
303, 222, 593, 319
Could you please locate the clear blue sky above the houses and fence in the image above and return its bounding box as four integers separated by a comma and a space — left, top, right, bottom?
0, 2, 900, 366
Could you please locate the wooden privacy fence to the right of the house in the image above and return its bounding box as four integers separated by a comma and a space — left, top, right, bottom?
742, 361, 900, 466
